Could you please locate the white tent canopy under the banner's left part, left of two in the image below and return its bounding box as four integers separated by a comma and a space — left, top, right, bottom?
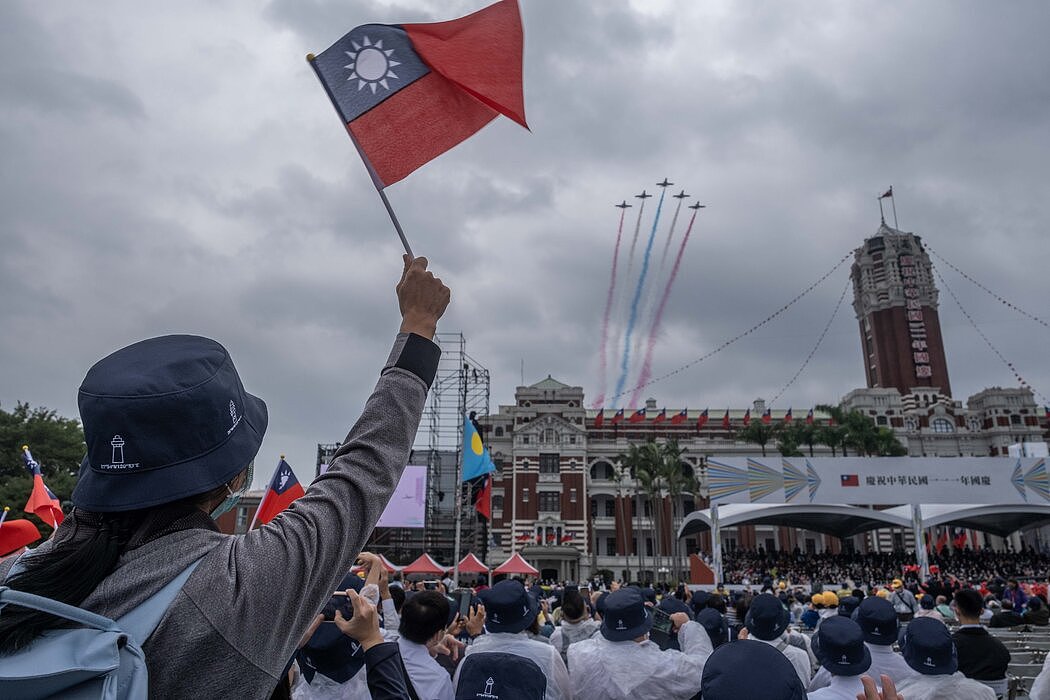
678, 504, 915, 537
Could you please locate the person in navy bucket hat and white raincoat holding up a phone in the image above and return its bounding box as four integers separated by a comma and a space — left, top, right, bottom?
569, 588, 713, 700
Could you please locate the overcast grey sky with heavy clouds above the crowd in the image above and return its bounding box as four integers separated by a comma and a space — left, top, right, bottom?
0, 0, 1050, 484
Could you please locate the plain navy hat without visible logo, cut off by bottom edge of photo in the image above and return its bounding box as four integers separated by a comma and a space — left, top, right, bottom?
700, 639, 805, 700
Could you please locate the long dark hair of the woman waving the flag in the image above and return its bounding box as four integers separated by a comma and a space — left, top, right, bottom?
0, 484, 227, 655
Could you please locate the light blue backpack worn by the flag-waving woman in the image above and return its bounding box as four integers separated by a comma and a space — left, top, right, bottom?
0, 559, 201, 700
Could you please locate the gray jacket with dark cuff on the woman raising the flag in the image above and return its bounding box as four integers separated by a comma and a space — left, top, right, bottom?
0, 334, 440, 700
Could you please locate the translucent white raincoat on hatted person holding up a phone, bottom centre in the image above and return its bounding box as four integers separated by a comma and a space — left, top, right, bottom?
569, 621, 713, 700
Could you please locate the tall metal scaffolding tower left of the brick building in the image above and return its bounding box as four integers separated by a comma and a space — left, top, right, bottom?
416, 333, 489, 566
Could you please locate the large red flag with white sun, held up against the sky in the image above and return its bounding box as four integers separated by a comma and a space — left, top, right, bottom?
307, 0, 528, 189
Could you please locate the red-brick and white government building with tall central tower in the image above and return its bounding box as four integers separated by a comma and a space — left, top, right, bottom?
481, 224, 1050, 580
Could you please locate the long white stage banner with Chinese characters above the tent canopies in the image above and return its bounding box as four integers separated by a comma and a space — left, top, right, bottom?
707, 455, 1050, 505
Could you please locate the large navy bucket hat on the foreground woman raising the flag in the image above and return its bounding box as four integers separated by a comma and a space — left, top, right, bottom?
72, 336, 267, 512
